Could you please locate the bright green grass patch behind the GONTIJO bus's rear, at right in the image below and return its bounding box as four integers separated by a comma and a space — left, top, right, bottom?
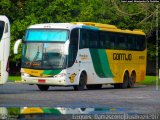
138, 76, 160, 85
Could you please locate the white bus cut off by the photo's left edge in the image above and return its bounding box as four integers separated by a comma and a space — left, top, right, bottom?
0, 15, 10, 84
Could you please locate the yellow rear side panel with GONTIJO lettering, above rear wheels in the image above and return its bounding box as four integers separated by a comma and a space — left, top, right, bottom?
106, 50, 146, 83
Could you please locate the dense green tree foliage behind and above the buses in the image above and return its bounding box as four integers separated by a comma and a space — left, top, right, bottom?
0, 0, 160, 61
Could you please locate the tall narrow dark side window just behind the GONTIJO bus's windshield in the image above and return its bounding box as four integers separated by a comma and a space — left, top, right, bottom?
68, 29, 79, 67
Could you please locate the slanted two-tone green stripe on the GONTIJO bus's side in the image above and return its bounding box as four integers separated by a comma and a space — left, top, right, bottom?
89, 49, 113, 78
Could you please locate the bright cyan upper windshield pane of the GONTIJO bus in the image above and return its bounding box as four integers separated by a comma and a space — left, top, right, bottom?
25, 29, 68, 42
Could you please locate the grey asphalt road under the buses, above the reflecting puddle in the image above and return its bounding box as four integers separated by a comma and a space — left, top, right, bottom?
0, 83, 160, 113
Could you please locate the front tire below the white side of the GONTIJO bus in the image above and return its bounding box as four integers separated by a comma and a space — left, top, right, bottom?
73, 72, 87, 91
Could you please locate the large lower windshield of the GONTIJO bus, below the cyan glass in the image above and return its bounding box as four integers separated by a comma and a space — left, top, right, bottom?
22, 43, 66, 69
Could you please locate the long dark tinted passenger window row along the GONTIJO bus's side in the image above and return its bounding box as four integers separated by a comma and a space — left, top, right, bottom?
80, 29, 146, 51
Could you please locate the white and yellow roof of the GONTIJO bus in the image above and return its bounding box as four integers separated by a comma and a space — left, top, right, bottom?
29, 22, 145, 35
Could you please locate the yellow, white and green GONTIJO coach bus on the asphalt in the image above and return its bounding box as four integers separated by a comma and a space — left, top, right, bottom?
14, 22, 147, 91
